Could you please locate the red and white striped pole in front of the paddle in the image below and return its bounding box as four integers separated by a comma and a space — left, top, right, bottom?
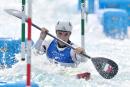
26, 0, 32, 87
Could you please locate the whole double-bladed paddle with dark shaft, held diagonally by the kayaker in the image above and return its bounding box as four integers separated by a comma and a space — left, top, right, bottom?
5, 9, 118, 79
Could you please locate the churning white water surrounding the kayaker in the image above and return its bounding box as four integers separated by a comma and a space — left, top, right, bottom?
0, 0, 130, 87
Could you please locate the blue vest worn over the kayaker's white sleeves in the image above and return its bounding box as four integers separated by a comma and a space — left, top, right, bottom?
47, 39, 74, 63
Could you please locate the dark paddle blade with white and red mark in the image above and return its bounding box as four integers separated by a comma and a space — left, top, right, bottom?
91, 57, 118, 79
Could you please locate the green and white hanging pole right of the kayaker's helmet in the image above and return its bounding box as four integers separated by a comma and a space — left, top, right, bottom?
81, 0, 85, 48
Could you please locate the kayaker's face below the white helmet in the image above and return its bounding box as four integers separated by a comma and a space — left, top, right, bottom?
56, 30, 71, 42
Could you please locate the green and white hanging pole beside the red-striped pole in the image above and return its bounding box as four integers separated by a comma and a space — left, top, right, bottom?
21, 0, 26, 61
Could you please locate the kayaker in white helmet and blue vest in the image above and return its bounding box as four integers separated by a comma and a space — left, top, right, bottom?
35, 21, 87, 67
